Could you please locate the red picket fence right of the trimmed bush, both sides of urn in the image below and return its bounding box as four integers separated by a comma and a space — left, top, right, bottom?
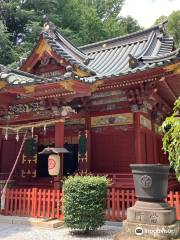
106, 187, 180, 221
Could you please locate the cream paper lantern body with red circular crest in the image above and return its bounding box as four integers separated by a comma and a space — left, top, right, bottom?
48, 154, 60, 176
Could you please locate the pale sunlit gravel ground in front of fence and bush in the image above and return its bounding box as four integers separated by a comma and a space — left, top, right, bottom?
0, 222, 120, 240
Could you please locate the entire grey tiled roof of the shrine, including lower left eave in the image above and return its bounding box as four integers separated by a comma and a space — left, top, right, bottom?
0, 21, 180, 85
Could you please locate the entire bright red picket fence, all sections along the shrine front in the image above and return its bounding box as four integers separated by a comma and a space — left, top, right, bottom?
2, 188, 180, 221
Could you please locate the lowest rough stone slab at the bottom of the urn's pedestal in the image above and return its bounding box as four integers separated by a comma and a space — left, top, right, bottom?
114, 221, 180, 240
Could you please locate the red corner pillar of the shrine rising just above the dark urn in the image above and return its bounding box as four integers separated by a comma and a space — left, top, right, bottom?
134, 112, 143, 164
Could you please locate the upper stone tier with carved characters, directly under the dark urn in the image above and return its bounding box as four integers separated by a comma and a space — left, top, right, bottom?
127, 201, 176, 225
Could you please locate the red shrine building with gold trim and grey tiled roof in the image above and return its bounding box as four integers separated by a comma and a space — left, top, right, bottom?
0, 20, 180, 189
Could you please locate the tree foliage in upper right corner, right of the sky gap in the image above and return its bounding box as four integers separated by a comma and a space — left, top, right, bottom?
155, 10, 180, 48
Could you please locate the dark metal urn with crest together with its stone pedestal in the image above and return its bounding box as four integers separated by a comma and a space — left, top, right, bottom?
114, 164, 180, 240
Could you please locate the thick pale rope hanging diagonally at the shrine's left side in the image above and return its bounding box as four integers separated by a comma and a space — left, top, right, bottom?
1, 131, 27, 210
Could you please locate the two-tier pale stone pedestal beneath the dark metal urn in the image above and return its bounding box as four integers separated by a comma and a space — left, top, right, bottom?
114, 201, 180, 240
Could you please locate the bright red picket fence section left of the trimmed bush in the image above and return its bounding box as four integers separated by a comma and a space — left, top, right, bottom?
5, 188, 64, 219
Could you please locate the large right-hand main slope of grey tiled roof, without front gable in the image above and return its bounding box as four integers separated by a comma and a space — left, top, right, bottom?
81, 25, 179, 81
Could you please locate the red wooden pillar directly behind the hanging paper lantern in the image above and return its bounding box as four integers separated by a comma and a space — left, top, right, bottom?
54, 121, 64, 189
